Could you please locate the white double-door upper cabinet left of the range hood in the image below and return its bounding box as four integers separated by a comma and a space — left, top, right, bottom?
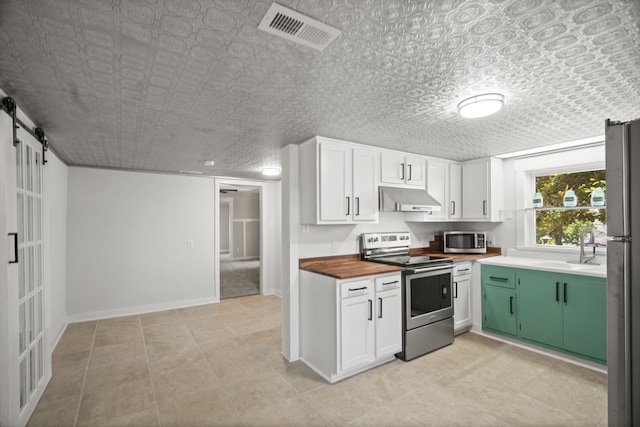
299, 137, 380, 224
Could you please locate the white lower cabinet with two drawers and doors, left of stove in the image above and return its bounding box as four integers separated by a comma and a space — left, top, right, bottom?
300, 270, 402, 383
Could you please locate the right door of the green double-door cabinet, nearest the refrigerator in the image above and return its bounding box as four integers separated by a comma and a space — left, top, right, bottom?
562, 275, 607, 361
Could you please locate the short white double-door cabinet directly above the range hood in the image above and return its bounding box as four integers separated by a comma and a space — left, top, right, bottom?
380, 151, 425, 188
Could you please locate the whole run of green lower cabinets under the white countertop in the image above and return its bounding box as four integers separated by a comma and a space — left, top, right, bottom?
482, 265, 607, 363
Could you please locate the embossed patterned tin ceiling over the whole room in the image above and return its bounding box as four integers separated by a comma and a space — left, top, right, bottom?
0, 0, 640, 178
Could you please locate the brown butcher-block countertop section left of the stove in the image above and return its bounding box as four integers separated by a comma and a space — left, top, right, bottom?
299, 255, 404, 279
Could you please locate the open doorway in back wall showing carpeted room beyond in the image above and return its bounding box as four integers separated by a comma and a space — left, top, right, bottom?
219, 184, 261, 299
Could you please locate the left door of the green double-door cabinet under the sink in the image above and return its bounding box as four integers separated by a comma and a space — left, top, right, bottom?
517, 270, 562, 347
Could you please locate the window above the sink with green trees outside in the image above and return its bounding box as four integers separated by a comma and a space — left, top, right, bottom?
535, 169, 607, 246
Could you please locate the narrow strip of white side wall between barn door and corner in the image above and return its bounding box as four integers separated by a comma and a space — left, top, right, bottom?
44, 151, 69, 346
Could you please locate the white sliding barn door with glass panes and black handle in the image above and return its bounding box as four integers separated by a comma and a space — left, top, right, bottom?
0, 114, 51, 425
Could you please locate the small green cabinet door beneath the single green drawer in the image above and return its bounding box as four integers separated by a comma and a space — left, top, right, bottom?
482, 283, 517, 336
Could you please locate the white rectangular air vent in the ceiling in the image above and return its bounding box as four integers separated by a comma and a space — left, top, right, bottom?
258, 3, 341, 50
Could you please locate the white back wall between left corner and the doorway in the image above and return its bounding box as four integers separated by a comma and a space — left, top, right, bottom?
67, 167, 216, 320
